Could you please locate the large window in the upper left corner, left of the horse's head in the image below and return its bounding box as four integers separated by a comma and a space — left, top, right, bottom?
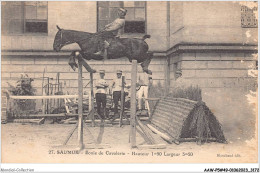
1, 1, 48, 34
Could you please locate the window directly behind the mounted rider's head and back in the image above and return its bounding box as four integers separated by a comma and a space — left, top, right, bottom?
97, 1, 146, 33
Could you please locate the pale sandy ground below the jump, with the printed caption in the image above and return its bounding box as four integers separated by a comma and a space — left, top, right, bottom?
1, 120, 258, 163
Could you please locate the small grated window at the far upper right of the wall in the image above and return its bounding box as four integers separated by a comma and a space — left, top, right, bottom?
241, 5, 258, 28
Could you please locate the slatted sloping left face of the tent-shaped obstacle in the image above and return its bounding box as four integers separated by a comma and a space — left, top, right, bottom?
147, 97, 197, 144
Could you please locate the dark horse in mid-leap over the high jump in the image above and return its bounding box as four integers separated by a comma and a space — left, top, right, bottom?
53, 26, 153, 74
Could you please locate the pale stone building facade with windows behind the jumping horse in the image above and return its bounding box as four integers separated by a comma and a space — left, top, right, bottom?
1, 1, 258, 134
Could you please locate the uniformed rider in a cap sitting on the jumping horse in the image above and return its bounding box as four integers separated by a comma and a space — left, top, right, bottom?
94, 8, 127, 56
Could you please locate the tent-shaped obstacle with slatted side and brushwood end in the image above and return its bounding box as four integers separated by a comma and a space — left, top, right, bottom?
147, 96, 226, 145
